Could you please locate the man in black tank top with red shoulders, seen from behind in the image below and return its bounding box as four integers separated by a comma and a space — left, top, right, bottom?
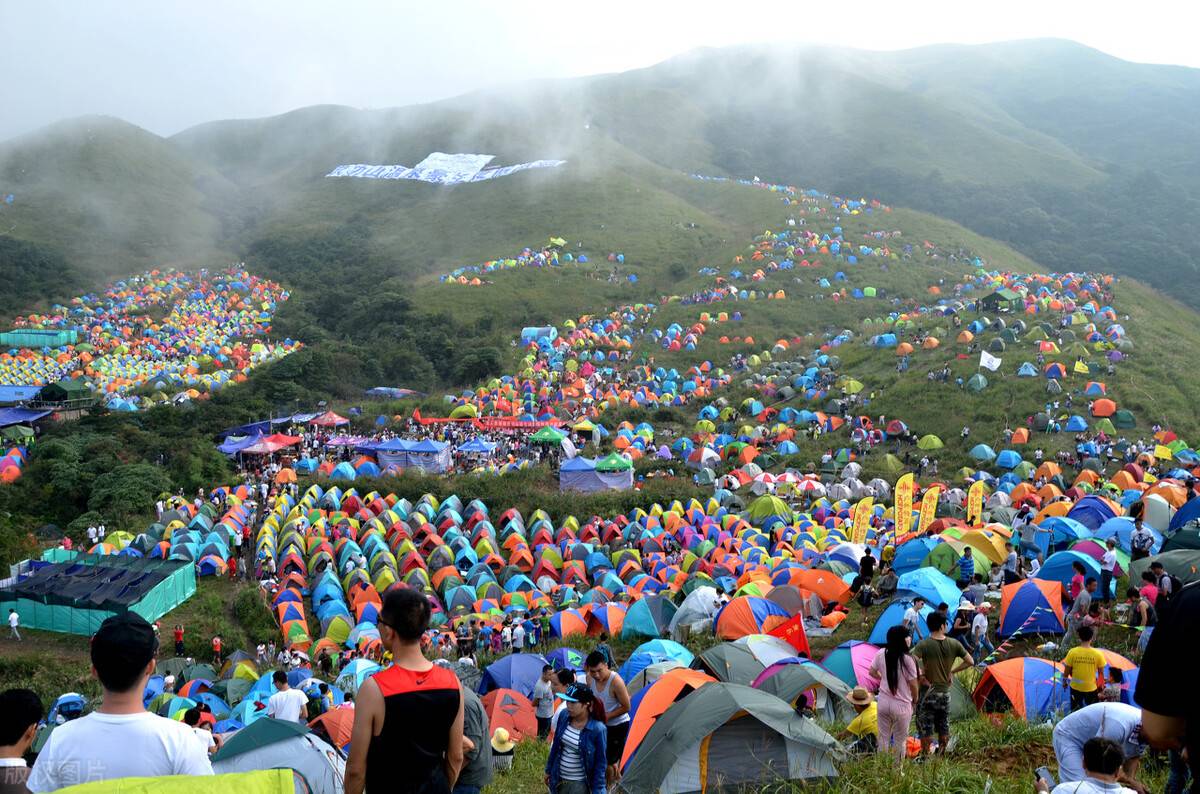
346, 587, 463, 794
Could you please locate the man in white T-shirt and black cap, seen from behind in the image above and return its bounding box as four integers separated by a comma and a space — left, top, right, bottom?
26, 612, 212, 793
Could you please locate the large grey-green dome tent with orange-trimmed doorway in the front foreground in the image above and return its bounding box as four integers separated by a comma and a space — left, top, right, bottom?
622, 684, 838, 794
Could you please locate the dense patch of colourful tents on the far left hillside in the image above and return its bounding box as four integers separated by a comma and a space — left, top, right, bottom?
0, 269, 299, 410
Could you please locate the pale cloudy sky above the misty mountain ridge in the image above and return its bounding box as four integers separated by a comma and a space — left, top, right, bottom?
0, 0, 1200, 139
